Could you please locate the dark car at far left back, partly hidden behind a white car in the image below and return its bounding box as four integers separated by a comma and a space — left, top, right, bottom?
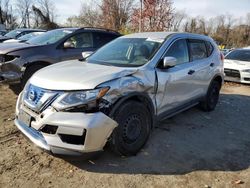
0, 28, 45, 43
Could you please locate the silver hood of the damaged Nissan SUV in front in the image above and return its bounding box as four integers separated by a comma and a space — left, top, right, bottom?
29, 60, 137, 90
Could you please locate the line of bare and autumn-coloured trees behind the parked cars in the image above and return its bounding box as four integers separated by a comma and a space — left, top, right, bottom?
0, 0, 250, 48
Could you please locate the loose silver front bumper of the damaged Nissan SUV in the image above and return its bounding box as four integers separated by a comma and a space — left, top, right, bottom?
15, 94, 117, 155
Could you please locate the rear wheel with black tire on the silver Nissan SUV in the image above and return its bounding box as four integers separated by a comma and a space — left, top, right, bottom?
200, 81, 221, 112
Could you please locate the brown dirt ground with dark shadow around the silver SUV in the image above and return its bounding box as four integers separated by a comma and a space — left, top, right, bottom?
0, 83, 250, 188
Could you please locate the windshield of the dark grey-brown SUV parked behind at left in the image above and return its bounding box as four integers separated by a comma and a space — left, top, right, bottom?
27, 29, 73, 45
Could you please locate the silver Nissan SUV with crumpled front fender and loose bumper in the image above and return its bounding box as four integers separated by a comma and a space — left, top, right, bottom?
15, 32, 224, 155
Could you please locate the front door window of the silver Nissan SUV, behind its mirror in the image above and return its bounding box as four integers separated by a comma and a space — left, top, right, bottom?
165, 39, 189, 64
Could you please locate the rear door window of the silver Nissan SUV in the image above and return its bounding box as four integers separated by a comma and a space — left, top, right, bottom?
189, 40, 207, 61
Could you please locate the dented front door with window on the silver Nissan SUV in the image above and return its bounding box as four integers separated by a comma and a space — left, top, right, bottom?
156, 39, 197, 114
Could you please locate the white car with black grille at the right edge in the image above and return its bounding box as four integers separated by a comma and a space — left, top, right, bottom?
224, 48, 250, 83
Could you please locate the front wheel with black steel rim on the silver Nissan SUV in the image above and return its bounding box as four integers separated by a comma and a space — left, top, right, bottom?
111, 101, 152, 156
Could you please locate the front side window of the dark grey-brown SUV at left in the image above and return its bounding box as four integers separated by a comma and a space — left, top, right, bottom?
66, 33, 93, 48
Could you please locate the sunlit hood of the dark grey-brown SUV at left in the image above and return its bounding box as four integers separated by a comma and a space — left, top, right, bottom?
0, 42, 36, 54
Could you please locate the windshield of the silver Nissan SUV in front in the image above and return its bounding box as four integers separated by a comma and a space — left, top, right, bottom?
88, 38, 164, 67
